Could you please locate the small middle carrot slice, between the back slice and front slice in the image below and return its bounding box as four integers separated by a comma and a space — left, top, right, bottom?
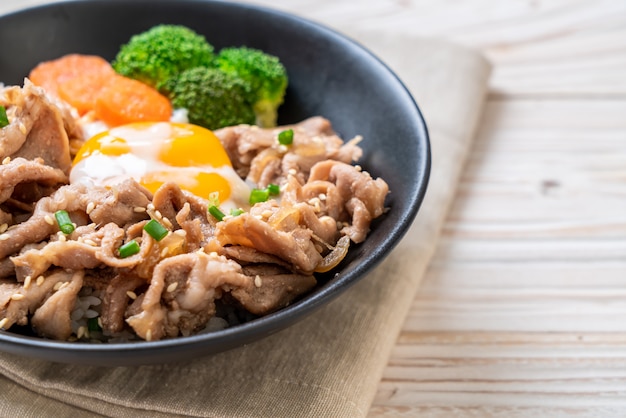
58, 73, 115, 115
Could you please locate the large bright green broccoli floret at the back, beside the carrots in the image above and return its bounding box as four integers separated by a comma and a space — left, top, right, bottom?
112, 25, 215, 90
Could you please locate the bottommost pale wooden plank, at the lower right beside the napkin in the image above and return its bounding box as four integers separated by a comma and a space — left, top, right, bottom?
370, 332, 626, 416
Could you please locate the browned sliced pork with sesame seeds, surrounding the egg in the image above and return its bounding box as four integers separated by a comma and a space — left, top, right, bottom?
0, 80, 388, 341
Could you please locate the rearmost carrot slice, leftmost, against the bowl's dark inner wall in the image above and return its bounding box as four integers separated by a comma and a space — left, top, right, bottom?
28, 54, 114, 96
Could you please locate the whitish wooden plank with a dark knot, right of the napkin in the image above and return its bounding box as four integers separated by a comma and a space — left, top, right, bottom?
445, 99, 626, 225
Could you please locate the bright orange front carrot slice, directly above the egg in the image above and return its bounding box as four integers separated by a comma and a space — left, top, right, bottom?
95, 75, 172, 126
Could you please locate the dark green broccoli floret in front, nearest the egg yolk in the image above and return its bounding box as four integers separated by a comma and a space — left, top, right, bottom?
164, 67, 255, 129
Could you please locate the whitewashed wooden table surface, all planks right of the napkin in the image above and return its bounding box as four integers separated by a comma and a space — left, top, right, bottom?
247, 0, 626, 417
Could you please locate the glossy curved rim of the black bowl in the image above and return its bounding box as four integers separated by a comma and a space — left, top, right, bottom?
0, 0, 431, 366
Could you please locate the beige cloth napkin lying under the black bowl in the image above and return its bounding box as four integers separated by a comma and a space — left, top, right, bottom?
0, 3, 490, 417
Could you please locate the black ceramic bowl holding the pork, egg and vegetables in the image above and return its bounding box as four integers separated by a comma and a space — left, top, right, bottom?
0, 0, 430, 365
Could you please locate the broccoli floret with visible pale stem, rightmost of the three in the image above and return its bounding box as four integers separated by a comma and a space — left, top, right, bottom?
215, 47, 288, 128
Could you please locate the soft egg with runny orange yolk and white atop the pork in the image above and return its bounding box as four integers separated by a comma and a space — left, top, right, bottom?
70, 122, 250, 209
